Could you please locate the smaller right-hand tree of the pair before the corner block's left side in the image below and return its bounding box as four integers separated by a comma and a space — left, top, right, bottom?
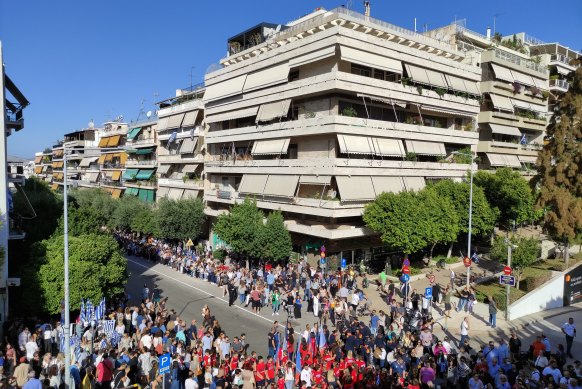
254, 211, 293, 261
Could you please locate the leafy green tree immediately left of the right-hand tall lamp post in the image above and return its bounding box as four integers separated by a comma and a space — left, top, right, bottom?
417, 187, 460, 258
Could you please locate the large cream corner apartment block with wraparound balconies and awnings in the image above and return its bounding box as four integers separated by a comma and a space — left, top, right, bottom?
203, 8, 481, 262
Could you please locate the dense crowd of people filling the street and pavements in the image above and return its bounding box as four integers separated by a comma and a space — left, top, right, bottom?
0, 234, 582, 389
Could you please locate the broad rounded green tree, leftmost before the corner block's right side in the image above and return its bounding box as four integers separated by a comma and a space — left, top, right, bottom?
363, 192, 427, 256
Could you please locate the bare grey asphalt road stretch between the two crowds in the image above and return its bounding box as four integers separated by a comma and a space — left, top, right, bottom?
126, 257, 278, 356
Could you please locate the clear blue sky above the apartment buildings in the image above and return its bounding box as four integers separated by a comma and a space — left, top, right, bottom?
0, 0, 582, 158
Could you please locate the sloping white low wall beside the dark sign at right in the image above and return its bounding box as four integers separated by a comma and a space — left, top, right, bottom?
509, 273, 564, 320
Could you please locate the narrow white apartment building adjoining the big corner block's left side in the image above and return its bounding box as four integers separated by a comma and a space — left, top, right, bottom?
156, 85, 205, 200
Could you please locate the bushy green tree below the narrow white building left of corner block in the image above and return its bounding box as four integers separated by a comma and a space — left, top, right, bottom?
156, 197, 205, 240
